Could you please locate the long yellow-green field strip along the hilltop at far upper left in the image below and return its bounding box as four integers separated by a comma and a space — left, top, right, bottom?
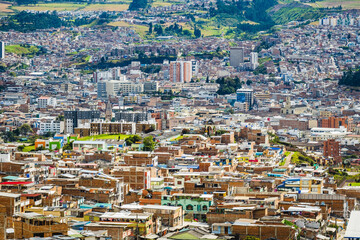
12, 3, 86, 11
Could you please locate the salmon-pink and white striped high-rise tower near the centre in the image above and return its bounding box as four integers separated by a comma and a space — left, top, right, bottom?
169, 61, 192, 83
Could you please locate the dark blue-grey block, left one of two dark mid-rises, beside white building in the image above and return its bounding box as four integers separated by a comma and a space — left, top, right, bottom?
64, 110, 100, 133
